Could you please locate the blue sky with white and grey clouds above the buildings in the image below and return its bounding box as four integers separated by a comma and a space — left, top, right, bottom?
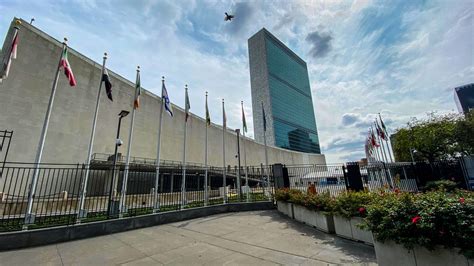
0, 0, 474, 163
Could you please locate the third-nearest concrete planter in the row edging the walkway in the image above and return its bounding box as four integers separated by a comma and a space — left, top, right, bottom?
293, 204, 334, 233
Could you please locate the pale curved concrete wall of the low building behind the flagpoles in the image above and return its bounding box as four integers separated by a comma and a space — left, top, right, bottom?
0, 21, 325, 166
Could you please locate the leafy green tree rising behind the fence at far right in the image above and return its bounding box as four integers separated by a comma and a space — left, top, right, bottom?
393, 111, 474, 162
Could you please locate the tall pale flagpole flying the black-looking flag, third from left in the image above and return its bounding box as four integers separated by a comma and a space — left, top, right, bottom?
79, 53, 107, 219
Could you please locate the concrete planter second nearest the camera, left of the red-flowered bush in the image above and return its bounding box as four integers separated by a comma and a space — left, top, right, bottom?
334, 215, 374, 245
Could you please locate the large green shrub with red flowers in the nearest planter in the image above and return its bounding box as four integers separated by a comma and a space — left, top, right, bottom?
365, 191, 474, 258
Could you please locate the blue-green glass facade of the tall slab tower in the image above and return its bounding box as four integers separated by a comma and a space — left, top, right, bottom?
265, 34, 321, 154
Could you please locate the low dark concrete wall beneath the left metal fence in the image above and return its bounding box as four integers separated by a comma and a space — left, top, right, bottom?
0, 202, 275, 250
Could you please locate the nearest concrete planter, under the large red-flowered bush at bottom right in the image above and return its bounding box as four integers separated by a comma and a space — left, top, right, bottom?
374, 241, 473, 266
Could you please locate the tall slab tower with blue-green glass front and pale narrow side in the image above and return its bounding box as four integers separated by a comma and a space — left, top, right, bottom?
248, 28, 321, 154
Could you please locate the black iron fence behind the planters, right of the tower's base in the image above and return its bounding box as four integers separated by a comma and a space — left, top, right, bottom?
273, 158, 471, 195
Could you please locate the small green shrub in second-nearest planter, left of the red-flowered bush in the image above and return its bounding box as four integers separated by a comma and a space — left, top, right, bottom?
333, 191, 375, 219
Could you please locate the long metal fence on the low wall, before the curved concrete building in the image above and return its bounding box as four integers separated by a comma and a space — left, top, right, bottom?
0, 163, 273, 232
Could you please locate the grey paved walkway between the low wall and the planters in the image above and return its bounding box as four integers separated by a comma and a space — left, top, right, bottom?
0, 211, 376, 266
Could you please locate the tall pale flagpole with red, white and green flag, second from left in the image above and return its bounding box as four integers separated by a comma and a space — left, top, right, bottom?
25, 38, 67, 224
